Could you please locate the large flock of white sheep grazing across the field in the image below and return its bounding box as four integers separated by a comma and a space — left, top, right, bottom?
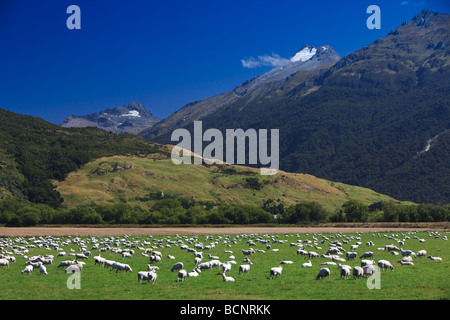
0, 231, 447, 292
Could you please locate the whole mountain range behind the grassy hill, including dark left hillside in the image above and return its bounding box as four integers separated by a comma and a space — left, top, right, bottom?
7, 10, 450, 208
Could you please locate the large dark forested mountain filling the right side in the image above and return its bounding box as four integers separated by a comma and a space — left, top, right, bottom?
145, 10, 450, 204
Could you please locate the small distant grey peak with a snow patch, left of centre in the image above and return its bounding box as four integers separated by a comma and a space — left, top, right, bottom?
61, 101, 159, 134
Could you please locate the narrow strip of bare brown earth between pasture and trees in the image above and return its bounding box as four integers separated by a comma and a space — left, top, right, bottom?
0, 223, 449, 237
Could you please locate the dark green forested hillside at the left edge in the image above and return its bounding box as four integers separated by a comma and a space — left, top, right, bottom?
0, 109, 168, 208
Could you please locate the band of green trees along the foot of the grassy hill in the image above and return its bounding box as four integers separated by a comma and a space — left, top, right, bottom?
0, 199, 450, 226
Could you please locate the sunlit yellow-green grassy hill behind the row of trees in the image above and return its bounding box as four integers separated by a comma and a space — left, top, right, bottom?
54, 156, 402, 210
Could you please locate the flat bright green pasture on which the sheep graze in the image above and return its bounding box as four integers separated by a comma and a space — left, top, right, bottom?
0, 231, 450, 300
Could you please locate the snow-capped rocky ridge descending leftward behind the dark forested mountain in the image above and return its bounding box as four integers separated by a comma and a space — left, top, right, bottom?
139, 46, 340, 142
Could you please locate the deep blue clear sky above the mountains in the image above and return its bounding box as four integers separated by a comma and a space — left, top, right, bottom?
0, 0, 450, 124
